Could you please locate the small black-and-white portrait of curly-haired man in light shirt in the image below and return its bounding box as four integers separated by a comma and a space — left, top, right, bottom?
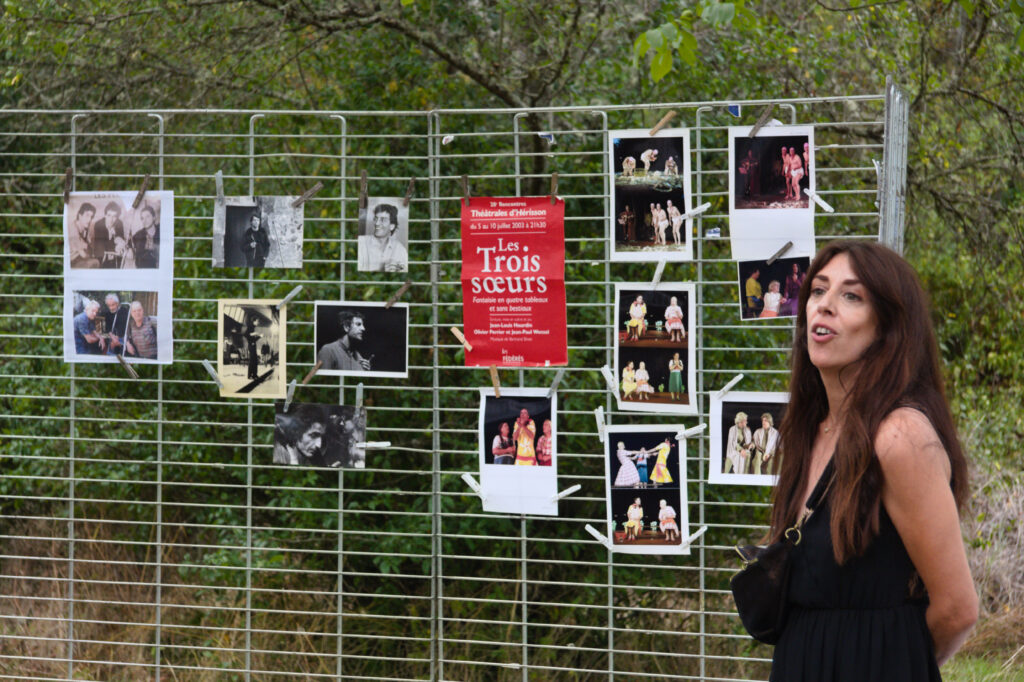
358, 197, 409, 272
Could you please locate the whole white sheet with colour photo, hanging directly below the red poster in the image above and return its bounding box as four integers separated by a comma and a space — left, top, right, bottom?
479, 388, 558, 516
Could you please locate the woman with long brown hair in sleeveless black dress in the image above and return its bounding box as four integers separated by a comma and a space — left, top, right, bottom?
770, 242, 978, 682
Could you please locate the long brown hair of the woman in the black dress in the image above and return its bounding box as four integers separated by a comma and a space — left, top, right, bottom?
770, 241, 968, 564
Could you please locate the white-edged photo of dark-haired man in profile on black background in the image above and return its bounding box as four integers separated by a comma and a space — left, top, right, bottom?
315, 301, 409, 379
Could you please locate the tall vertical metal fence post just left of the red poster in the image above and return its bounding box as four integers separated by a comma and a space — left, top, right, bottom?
427, 112, 444, 682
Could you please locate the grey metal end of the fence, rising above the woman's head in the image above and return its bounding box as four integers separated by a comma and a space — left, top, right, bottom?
879, 76, 910, 253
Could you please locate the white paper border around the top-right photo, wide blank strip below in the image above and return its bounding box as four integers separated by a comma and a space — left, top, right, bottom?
728, 125, 817, 260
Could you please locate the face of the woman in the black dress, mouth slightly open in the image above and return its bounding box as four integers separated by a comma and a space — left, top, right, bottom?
806, 253, 879, 372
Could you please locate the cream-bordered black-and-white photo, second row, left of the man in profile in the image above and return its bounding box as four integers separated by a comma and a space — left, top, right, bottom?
217, 299, 287, 398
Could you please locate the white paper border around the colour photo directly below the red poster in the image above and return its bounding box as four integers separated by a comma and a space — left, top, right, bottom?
476, 386, 558, 516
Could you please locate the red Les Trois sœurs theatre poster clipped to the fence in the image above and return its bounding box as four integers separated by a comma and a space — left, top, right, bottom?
462, 197, 568, 367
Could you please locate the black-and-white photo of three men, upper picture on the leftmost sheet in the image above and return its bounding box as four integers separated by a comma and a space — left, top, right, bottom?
65, 193, 160, 269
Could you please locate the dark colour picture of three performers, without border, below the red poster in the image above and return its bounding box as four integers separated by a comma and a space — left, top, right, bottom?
480, 393, 555, 467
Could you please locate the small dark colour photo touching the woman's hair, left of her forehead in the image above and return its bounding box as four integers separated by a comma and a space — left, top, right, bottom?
736, 256, 811, 321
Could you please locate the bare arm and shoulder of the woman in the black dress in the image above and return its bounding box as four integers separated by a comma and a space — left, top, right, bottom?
874, 408, 978, 666
